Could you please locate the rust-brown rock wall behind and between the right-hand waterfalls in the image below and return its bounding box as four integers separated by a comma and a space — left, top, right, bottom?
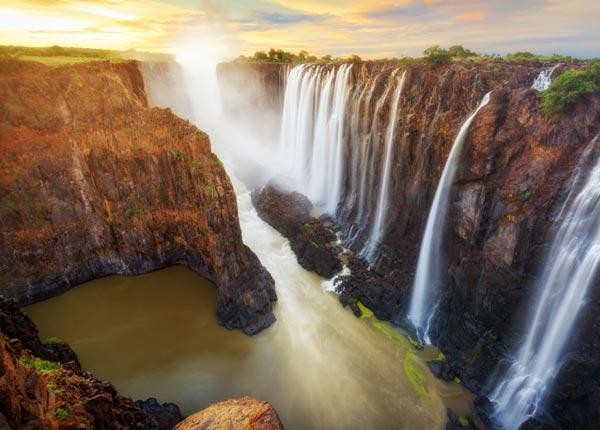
220, 61, 600, 428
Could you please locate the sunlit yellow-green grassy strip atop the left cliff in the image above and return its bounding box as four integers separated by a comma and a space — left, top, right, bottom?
0, 45, 173, 66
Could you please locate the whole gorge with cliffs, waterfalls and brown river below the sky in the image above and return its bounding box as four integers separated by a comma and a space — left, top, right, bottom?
0, 48, 600, 429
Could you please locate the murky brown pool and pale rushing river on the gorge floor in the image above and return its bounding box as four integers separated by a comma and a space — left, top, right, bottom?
26, 183, 470, 430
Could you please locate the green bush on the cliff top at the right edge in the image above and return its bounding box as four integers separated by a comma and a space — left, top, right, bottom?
542, 60, 600, 117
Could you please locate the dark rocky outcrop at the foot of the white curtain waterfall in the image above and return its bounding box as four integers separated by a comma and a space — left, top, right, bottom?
252, 181, 342, 278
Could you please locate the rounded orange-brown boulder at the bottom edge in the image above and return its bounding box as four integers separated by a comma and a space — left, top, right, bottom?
173, 397, 283, 430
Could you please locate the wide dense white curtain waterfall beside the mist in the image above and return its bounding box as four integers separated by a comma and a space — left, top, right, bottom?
280, 64, 352, 214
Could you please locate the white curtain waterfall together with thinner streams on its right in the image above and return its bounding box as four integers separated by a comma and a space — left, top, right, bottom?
280, 64, 406, 262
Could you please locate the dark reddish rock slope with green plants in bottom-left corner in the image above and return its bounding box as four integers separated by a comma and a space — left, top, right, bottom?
0, 297, 183, 430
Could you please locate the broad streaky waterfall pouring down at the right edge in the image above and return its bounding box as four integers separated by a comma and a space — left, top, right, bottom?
490, 138, 600, 429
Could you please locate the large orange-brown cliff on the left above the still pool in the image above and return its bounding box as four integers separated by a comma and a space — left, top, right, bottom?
0, 61, 276, 334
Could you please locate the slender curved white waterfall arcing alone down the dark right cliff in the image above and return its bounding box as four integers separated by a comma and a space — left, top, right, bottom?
407, 93, 490, 343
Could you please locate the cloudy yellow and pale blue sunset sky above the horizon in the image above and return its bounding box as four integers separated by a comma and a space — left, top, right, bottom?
0, 0, 600, 58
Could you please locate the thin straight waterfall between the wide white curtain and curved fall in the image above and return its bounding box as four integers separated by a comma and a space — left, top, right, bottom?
363, 71, 406, 262
